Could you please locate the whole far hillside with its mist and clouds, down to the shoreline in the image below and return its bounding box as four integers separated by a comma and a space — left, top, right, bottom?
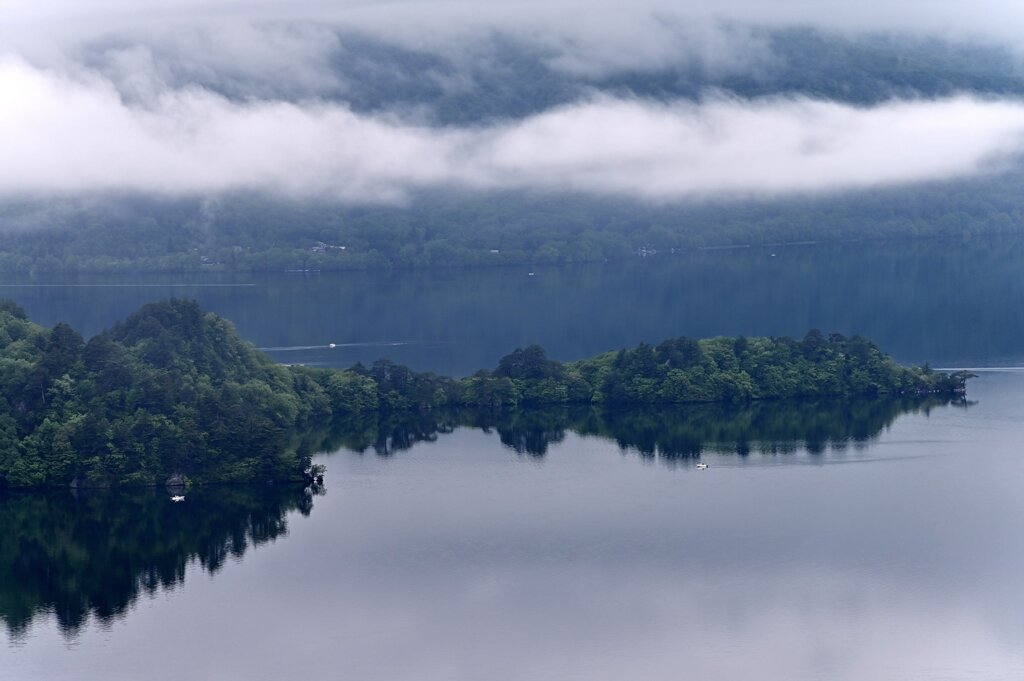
6, 0, 1024, 270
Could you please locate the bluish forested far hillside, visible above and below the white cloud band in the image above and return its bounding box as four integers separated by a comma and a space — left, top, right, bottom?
6, 26, 1024, 272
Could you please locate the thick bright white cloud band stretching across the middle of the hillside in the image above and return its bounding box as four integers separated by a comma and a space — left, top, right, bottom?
0, 59, 1024, 202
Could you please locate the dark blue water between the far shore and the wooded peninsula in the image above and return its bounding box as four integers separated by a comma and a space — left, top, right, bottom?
0, 239, 1024, 375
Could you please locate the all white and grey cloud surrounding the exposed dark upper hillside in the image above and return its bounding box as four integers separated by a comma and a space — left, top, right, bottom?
6, 0, 1024, 201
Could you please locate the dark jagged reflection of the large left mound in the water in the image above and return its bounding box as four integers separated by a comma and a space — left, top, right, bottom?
0, 485, 312, 639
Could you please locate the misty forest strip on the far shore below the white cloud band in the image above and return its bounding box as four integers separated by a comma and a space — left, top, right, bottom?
6, 166, 1024, 274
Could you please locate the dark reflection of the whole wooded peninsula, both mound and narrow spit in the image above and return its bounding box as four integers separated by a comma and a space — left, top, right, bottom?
0, 397, 968, 640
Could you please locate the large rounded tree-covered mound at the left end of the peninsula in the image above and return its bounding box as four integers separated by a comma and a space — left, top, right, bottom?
0, 300, 331, 486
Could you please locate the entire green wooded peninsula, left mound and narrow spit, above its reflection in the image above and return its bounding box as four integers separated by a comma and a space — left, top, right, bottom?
0, 300, 971, 487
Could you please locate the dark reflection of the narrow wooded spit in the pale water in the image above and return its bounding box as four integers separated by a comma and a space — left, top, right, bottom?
317, 397, 969, 463
